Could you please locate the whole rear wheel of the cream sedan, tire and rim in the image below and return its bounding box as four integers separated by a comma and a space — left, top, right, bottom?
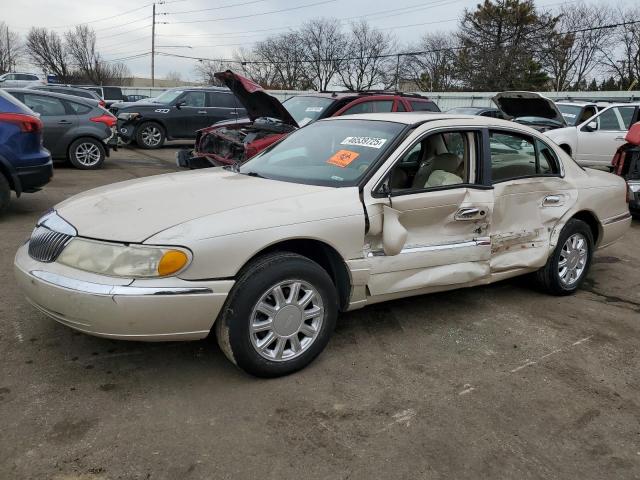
537, 218, 594, 295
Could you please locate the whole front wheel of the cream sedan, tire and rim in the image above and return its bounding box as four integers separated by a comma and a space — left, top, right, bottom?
216, 253, 338, 377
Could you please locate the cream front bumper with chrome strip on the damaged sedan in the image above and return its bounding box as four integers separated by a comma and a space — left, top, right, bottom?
14, 244, 234, 341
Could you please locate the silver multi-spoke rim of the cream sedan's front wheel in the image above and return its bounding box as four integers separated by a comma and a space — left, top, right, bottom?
250, 280, 324, 362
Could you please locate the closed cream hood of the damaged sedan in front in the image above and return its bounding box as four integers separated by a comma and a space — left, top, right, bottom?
55, 168, 333, 243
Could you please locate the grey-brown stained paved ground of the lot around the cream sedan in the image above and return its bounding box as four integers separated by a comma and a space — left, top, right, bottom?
0, 148, 640, 480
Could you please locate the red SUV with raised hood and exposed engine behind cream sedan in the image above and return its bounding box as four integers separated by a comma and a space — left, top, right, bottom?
177, 70, 440, 169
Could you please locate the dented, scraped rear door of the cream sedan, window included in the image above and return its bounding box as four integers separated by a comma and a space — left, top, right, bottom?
489, 130, 577, 274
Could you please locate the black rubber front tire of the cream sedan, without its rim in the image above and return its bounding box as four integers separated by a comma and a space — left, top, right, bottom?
215, 252, 338, 377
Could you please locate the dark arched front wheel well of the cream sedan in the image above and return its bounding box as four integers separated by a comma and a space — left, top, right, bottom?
243, 238, 351, 310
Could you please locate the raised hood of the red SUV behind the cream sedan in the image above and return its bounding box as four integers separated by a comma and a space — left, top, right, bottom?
214, 70, 298, 128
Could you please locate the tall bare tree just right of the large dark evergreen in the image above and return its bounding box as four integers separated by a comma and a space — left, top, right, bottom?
540, 4, 615, 91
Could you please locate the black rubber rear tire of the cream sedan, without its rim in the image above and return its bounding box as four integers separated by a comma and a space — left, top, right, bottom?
536, 218, 594, 295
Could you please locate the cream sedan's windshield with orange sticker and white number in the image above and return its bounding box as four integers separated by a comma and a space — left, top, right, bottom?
239, 119, 405, 187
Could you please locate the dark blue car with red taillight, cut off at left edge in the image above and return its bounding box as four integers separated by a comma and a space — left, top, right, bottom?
0, 89, 53, 212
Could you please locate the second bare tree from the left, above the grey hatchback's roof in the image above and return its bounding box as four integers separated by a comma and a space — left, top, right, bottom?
25, 27, 72, 82
